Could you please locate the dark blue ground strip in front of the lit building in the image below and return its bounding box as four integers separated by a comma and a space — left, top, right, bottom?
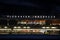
0, 34, 60, 39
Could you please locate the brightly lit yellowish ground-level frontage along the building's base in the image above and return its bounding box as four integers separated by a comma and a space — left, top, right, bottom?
0, 29, 60, 35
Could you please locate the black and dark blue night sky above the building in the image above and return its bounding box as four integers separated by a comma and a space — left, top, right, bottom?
0, 0, 60, 15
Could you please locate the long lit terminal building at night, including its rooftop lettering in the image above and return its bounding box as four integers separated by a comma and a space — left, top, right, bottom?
0, 15, 60, 35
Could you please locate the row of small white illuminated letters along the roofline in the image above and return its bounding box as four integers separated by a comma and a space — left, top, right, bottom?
6, 15, 55, 19
